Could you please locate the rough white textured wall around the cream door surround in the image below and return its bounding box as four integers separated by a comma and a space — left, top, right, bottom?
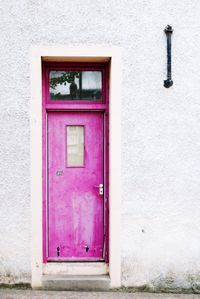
0, 0, 200, 289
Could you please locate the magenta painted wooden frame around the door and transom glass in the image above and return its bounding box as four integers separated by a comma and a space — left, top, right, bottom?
42, 61, 110, 263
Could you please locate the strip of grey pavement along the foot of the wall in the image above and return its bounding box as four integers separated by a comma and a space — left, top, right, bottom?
0, 289, 200, 299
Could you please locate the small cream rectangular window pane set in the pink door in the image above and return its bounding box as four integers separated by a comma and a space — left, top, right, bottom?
66, 126, 84, 167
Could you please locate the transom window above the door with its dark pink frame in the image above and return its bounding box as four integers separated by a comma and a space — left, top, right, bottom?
43, 62, 109, 105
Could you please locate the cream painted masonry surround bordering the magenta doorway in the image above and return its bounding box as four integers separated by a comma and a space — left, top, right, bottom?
30, 45, 121, 288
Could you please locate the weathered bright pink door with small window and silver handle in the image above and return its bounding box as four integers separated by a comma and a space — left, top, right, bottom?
48, 112, 104, 261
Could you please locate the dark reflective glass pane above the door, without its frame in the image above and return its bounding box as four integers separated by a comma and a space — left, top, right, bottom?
49, 71, 102, 101
